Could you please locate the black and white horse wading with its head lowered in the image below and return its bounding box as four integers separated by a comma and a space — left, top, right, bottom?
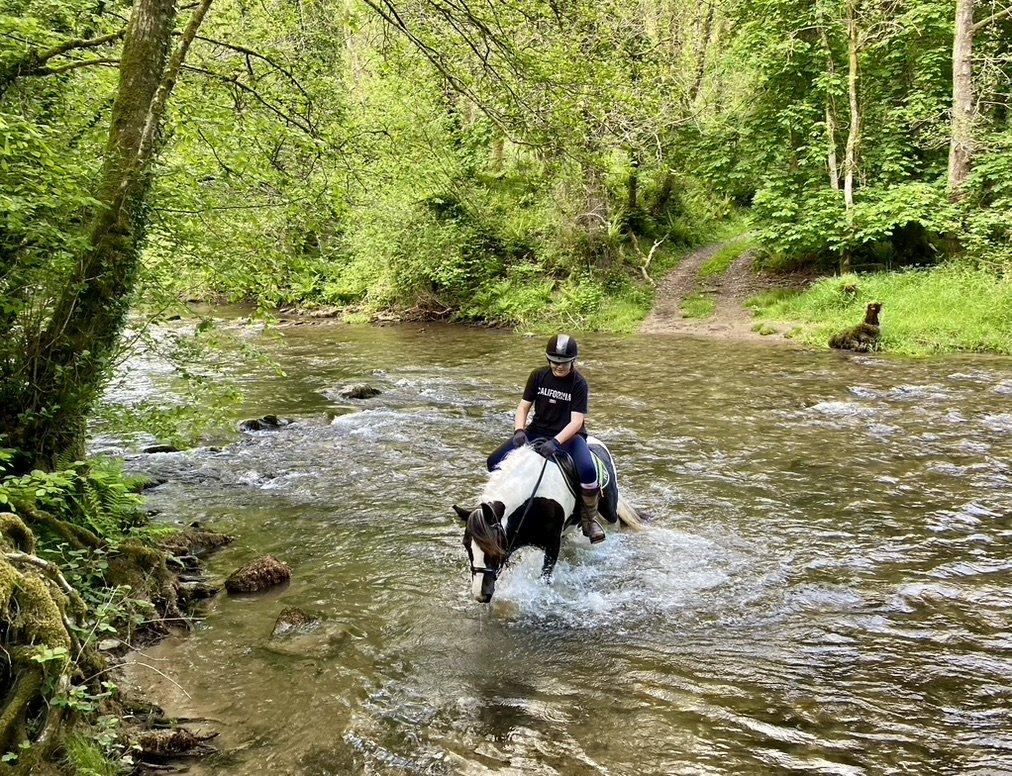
453, 437, 643, 604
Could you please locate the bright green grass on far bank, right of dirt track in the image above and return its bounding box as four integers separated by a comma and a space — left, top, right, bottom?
749, 263, 1012, 356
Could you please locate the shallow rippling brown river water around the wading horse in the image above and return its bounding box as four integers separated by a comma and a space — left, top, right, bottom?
106, 325, 1012, 774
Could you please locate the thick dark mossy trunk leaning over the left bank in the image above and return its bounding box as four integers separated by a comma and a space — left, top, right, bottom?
3, 0, 184, 467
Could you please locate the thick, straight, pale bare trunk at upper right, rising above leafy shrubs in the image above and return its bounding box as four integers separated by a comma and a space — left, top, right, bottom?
948, 0, 975, 192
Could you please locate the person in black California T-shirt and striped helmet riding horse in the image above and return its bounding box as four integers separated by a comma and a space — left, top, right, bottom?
488, 334, 604, 544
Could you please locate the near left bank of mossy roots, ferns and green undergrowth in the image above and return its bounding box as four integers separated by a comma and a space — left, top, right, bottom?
0, 449, 223, 776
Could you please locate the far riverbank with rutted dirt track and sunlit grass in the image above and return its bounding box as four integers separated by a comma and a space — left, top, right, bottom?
641, 236, 1012, 356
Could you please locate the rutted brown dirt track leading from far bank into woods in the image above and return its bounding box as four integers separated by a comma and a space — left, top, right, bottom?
640, 238, 811, 345
